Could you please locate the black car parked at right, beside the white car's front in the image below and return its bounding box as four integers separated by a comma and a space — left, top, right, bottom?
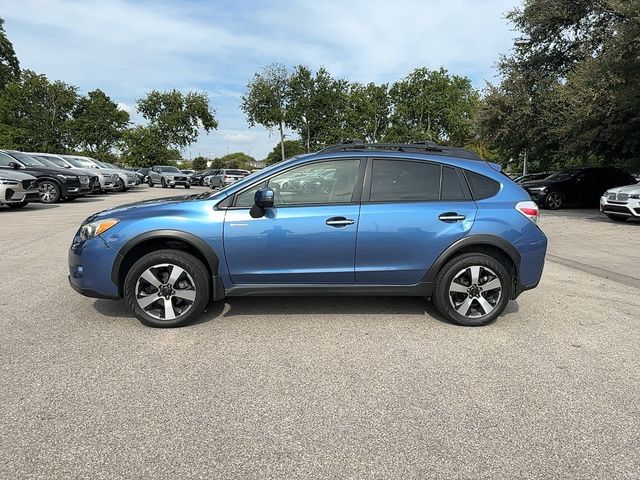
522, 167, 636, 210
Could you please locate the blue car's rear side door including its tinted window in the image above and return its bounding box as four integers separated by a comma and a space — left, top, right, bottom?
356, 159, 476, 285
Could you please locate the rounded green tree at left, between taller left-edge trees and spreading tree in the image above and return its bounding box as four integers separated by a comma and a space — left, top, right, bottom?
71, 89, 129, 154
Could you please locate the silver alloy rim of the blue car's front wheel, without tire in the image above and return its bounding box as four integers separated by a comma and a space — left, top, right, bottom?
135, 263, 196, 320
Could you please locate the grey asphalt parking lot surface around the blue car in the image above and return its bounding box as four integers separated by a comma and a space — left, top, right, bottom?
0, 186, 640, 479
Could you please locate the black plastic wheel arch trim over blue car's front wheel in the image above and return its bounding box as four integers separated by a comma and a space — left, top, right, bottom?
111, 230, 220, 297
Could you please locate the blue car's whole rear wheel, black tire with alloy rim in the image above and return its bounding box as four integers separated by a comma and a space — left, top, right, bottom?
432, 253, 512, 327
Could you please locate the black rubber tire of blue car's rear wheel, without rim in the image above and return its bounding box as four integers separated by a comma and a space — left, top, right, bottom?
432, 253, 511, 327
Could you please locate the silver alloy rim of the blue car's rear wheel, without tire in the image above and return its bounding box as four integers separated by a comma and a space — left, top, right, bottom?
449, 265, 502, 318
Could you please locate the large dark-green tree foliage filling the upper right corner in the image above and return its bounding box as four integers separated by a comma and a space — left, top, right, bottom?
478, 0, 640, 170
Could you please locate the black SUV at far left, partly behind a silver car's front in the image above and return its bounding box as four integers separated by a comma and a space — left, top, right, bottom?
0, 150, 89, 203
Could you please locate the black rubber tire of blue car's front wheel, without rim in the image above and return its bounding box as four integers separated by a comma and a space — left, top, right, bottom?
124, 250, 211, 328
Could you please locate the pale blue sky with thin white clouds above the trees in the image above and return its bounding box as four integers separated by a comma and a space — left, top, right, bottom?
0, 0, 519, 159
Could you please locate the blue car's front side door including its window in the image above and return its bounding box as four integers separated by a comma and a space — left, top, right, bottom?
224, 158, 365, 284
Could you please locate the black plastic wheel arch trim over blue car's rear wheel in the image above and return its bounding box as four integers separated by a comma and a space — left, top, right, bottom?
423, 235, 520, 291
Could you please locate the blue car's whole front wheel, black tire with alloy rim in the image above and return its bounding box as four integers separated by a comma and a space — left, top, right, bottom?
124, 250, 210, 328
